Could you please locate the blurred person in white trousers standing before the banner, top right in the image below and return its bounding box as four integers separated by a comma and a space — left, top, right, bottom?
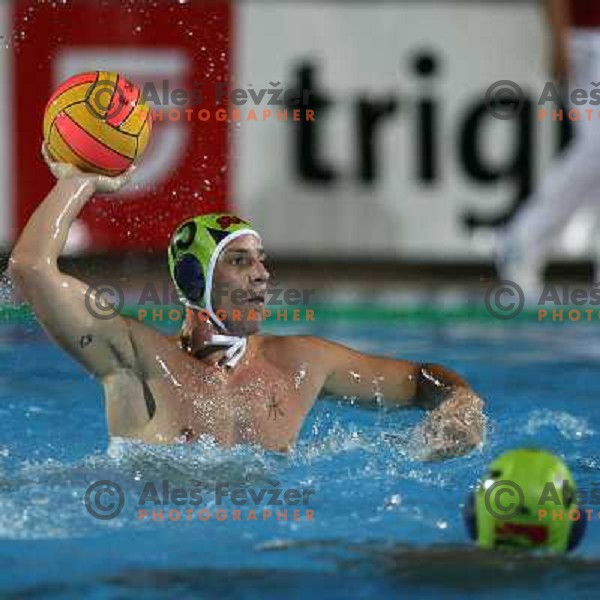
496, 0, 600, 301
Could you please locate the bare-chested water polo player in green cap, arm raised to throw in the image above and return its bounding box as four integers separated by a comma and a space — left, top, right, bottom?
9, 151, 485, 459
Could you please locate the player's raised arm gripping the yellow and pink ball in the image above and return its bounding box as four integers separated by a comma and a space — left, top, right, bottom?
9, 147, 132, 378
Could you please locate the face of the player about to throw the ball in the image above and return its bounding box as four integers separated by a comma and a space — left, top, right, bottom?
212, 235, 269, 335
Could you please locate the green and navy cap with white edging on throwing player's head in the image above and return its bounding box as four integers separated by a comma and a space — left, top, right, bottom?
169, 213, 260, 329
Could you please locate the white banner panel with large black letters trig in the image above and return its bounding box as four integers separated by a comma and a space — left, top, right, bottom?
230, 2, 576, 260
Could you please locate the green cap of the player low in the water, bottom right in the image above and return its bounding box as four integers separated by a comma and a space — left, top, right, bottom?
464, 449, 586, 552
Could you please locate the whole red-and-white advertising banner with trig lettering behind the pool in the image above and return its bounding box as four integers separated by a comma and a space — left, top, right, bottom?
0, 0, 592, 261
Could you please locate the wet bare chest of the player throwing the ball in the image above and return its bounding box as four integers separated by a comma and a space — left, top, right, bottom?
138, 342, 318, 450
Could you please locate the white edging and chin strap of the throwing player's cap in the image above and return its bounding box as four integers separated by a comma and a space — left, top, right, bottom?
184, 229, 261, 369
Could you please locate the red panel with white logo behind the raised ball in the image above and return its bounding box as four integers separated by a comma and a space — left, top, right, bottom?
13, 0, 231, 251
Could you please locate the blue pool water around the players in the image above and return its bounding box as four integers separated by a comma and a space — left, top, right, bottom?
0, 321, 600, 599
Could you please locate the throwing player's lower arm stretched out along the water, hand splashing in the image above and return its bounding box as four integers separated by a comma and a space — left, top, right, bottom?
311, 338, 485, 459
